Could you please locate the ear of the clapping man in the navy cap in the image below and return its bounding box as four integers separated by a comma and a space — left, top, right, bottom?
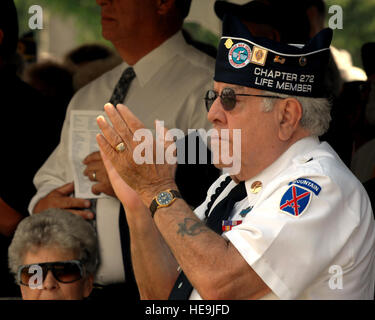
277, 98, 303, 141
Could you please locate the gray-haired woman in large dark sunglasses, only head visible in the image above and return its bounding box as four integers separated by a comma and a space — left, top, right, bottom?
8, 209, 98, 300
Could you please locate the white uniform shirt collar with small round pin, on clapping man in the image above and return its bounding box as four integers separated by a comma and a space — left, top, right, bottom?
245, 136, 320, 195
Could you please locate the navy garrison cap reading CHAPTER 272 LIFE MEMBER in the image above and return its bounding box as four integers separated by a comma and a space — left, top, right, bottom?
214, 14, 333, 98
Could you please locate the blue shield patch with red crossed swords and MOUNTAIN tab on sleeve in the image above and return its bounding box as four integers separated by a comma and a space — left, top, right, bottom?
280, 178, 322, 217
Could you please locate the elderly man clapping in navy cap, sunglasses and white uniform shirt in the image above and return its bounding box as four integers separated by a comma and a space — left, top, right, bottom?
97, 15, 375, 299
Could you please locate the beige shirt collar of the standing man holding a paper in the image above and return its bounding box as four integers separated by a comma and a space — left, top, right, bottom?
133, 31, 187, 86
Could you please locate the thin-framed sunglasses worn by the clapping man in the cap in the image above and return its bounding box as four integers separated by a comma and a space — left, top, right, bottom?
204, 88, 284, 111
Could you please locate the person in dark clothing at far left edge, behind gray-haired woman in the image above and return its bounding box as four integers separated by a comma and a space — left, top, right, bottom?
0, 0, 59, 297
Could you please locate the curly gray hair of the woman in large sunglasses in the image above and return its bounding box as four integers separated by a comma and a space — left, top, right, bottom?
8, 208, 98, 275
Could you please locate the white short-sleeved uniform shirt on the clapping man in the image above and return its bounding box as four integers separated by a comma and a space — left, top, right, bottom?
190, 137, 375, 299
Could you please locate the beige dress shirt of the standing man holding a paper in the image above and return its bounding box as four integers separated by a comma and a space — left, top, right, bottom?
29, 32, 215, 284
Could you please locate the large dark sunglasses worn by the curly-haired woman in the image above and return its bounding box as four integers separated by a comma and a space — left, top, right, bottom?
17, 260, 85, 286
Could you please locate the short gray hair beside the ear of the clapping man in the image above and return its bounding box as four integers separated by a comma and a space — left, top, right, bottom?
263, 91, 331, 137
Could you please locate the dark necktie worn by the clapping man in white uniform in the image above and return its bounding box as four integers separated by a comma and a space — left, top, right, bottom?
169, 178, 247, 300
